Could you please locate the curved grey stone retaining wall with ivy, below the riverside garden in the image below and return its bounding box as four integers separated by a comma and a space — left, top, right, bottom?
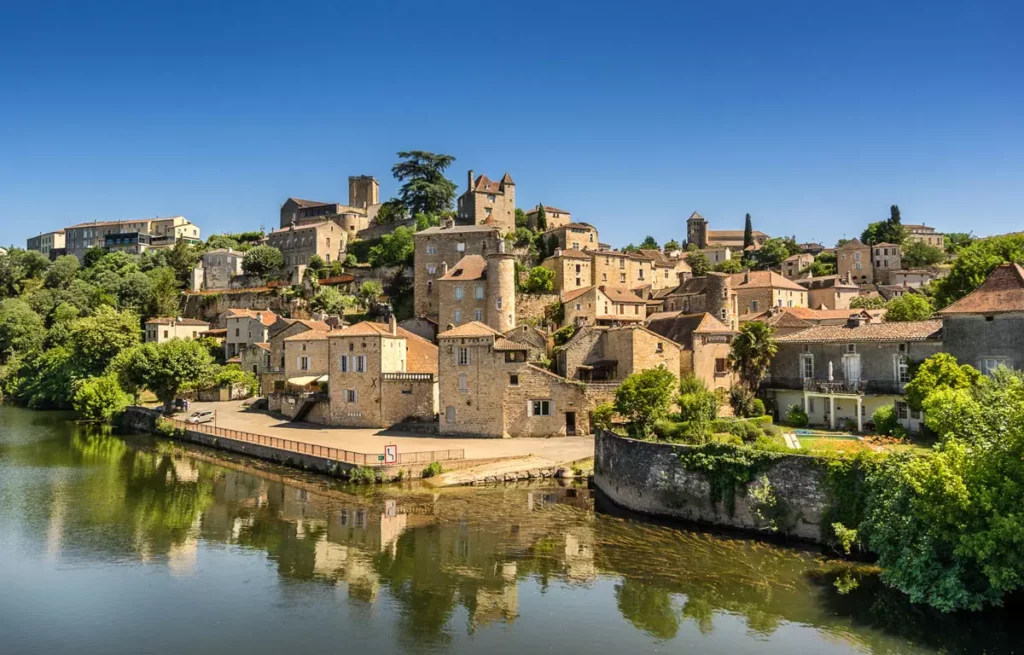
594, 430, 826, 541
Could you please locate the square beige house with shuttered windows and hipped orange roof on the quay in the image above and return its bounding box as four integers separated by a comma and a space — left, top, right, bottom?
327, 316, 438, 428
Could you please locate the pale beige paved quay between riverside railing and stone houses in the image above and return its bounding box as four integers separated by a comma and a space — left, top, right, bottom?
175, 401, 594, 464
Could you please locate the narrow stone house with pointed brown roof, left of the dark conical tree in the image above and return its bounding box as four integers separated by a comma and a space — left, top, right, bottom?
647, 311, 736, 390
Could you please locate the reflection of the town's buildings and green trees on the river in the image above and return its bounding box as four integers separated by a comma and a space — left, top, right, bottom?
0, 408, 1018, 653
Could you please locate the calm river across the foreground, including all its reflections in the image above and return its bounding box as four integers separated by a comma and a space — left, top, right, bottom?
0, 407, 1024, 655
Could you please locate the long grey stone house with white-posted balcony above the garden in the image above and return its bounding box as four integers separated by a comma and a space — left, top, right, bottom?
762, 314, 943, 431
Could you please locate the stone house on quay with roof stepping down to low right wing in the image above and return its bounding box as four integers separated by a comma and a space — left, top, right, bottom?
437, 322, 592, 438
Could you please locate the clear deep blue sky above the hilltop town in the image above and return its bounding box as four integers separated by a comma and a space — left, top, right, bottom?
0, 0, 1024, 247
